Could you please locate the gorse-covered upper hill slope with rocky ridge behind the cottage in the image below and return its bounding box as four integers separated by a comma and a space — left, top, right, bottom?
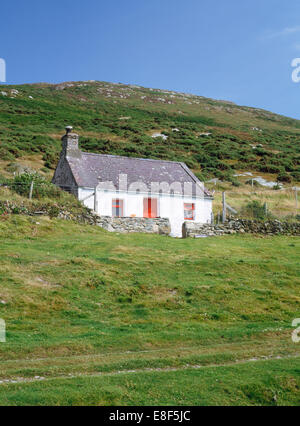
0, 81, 300, 182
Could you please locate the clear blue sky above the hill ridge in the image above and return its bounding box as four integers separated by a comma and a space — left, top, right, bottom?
0, 0, 300, 119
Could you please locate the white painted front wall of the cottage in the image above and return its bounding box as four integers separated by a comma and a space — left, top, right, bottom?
78, 188, 212, 237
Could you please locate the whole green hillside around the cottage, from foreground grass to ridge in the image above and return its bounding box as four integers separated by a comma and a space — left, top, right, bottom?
0, 82, 300, 405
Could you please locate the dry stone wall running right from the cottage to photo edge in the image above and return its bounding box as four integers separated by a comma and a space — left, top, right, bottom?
182, 219, 300, 238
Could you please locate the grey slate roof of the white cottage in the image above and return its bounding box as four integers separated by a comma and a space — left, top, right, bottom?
67, 152, 211, 197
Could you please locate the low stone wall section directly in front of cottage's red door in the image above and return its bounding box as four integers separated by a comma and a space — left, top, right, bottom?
96, 216, 171, 235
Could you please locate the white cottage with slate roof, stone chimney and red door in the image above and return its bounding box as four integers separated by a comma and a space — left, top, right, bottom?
52, 127, 212, 237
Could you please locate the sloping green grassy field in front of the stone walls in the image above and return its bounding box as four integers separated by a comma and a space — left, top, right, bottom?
0, 216, 300, 405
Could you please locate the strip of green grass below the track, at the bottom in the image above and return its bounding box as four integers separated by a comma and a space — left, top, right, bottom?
0, 360, 300, 406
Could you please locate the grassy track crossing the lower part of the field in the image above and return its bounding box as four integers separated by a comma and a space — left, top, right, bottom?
0, 333, 299, 383
